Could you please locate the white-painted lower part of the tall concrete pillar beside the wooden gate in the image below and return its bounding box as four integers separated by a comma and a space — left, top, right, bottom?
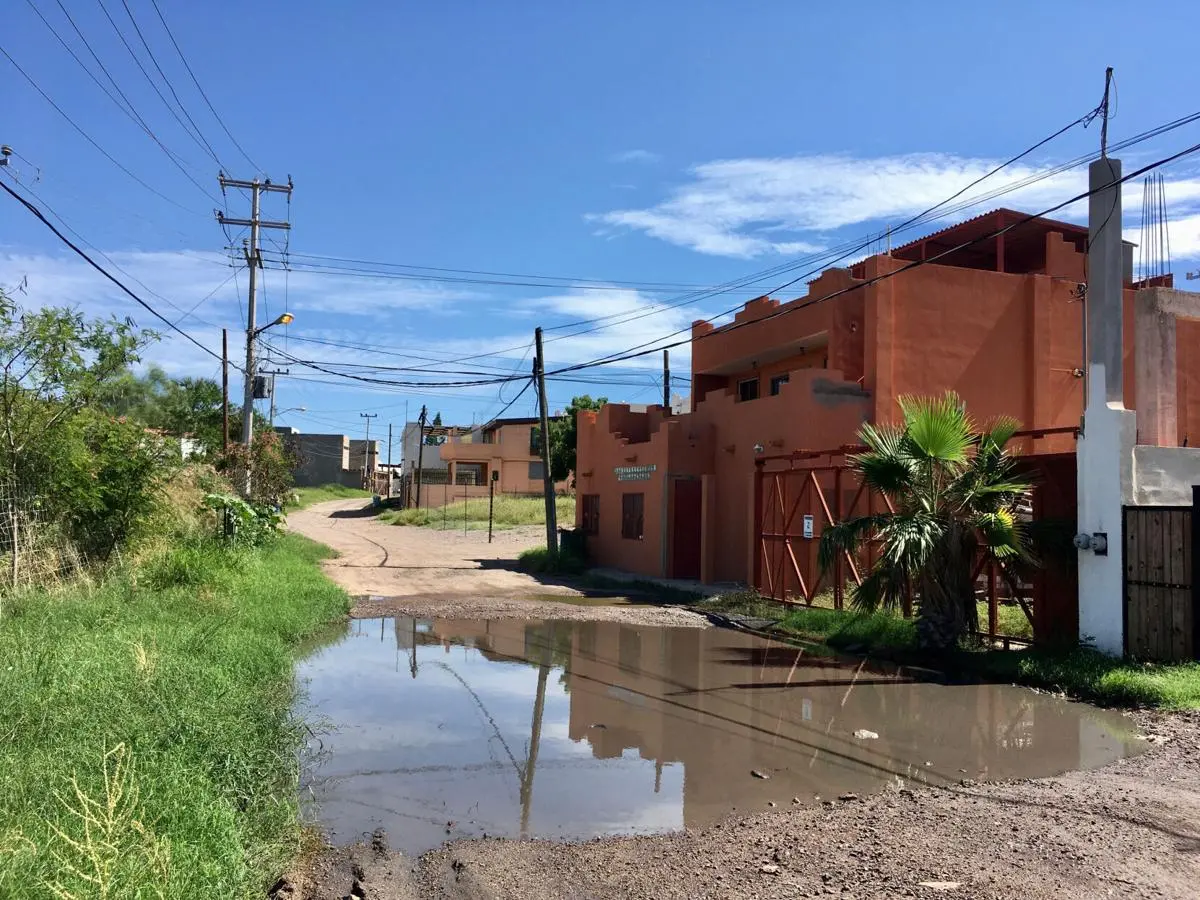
1076, 362, 1138, 656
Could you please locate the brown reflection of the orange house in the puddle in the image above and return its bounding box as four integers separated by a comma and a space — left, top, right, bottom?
424, 620, 1104, 826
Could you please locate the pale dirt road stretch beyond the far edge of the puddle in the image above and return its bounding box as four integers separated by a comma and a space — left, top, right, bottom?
288, 499, 707, 625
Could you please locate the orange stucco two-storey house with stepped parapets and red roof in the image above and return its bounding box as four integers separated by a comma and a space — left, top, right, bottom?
576, 209, 1200, 592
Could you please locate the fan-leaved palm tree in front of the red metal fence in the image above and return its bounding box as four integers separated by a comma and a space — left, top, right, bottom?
818, 392, 1032, 649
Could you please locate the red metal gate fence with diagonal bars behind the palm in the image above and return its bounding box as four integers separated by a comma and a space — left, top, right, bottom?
754, 428, 1078, 646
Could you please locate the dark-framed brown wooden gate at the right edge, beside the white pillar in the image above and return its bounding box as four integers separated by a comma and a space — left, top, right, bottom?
1122, 506, 1200, 661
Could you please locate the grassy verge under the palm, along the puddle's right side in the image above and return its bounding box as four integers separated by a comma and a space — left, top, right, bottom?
696, 593, 1200, 709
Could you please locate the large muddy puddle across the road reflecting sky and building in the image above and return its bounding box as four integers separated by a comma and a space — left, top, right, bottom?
298, 618, 1141, 854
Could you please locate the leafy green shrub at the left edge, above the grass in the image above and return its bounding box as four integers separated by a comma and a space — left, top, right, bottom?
0, 293, 172, 580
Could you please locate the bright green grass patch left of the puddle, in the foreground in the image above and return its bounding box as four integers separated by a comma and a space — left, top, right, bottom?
0, 535, 348, 900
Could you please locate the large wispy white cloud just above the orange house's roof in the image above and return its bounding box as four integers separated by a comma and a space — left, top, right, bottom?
588, 154, 1200, 258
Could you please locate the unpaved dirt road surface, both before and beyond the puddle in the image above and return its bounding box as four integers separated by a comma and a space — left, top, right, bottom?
288, 503, 1200, 900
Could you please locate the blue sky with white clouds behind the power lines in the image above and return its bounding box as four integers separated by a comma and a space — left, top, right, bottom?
0, 0, 1200, 448
